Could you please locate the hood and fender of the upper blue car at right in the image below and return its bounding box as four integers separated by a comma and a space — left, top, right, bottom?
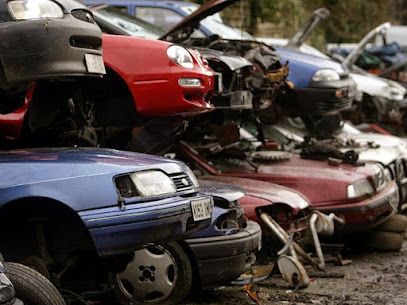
276, 47, 347, 88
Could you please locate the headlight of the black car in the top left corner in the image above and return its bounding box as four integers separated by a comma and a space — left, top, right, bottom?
7, 0, 64, 20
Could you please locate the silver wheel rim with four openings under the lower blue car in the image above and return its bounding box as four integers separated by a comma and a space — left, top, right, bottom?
116, 245, 178, 303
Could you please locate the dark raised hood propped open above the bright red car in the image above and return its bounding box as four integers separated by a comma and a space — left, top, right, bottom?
160, 0, 238, 43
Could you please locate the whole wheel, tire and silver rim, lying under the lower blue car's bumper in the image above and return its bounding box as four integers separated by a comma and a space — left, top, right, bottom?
115, 243, 192, 305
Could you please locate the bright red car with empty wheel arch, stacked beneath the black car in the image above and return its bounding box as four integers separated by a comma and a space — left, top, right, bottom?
0, 35, 215, 146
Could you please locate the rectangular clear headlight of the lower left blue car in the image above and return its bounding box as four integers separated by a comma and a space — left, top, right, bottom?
130, 171, 177, 197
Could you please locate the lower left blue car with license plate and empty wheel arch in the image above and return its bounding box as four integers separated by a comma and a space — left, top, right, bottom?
0, 148, 213, 289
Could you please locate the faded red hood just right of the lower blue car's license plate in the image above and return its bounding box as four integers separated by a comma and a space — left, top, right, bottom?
200, 176, 309, 210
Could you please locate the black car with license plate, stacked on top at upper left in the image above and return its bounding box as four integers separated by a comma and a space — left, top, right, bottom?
0, 0, 105, 113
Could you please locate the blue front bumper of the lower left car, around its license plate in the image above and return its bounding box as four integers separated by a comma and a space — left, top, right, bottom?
79, 195, 212, 256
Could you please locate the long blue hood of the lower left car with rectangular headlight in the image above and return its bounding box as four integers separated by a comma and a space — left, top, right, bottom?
0, 148, 190, 187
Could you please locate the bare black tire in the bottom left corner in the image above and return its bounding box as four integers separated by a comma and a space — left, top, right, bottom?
5, 263, 65, 305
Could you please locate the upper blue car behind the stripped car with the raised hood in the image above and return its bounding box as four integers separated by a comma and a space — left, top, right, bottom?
85, 0, 356, 116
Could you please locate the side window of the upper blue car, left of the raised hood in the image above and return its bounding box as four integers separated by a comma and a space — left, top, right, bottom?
136, 6, 183, 31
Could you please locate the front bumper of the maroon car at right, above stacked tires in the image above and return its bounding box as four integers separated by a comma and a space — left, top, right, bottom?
313, 181, 398, 232
